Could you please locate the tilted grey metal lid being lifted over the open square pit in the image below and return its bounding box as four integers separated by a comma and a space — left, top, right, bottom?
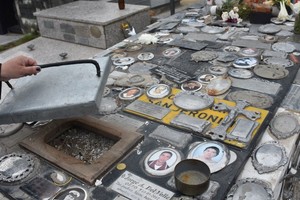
0, 57, 111, 124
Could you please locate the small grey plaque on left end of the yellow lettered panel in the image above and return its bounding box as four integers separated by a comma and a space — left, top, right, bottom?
126, 100, 170, 119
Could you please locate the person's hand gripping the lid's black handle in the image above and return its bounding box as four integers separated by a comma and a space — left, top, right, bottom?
0, 55, 41, 81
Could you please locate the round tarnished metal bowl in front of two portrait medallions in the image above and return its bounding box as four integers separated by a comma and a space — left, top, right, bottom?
174, 159, 210, 196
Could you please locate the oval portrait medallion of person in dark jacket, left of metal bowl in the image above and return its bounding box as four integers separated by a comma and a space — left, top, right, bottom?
144, 147, 181, 176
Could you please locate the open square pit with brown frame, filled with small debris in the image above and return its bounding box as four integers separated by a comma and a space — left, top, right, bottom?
21, 117, 143, 184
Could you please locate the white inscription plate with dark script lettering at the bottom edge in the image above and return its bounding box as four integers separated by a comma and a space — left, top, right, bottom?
111, 171, 174, 200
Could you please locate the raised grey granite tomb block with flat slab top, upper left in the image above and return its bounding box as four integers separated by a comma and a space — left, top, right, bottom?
34, 1, 150, 49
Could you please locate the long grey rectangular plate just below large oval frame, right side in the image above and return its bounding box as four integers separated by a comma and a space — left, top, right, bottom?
231, 78, 281, 95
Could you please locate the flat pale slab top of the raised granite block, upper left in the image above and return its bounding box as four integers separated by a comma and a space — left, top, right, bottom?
34, 1, 150, 25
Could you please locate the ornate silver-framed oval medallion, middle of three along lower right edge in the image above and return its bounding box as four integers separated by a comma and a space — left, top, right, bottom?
252, 141, 288, 174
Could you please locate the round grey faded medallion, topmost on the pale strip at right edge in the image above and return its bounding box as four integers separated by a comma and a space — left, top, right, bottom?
270, 112, 300, 139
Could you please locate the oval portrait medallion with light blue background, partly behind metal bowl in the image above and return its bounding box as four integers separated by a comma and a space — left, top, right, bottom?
187, 141, 230, 173
